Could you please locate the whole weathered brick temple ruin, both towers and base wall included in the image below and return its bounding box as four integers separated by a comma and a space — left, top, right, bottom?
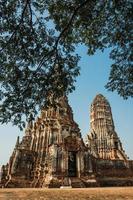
0, 94, 133, 187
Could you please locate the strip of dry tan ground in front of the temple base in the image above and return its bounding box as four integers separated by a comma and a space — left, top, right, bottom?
0, 187, 133, 200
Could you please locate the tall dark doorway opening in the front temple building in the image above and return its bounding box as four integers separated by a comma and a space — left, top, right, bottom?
68, 151, 77, 177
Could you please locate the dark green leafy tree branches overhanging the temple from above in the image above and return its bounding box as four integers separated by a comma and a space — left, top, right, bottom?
0, 0, 133, 127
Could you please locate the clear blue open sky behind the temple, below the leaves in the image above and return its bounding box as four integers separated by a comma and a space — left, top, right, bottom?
0, 47, 133, 166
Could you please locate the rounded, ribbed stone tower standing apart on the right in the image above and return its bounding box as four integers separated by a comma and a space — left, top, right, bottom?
88, 94, 127, 160
